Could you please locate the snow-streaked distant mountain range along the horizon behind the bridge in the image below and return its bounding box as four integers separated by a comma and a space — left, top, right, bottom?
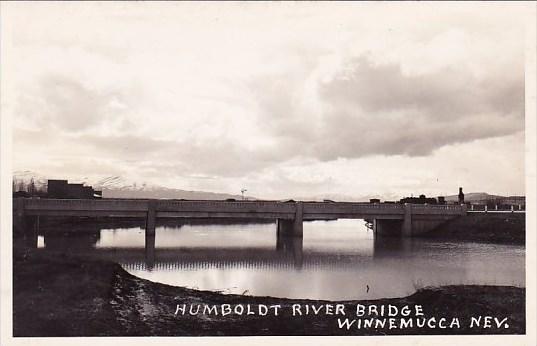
13, 171, 520, 202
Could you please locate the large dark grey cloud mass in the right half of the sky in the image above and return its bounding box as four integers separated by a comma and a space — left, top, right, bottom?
250, 56, 524, 161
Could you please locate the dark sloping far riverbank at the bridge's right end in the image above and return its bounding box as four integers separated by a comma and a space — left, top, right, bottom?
421, 213, 526, 245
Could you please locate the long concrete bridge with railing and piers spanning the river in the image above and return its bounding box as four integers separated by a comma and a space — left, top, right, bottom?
13, 198, 467, 237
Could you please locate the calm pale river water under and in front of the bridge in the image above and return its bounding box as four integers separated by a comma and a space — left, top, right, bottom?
34, 220, 525, 300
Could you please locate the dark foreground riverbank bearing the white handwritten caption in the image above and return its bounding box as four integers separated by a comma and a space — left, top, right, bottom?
13, 250, 525, 336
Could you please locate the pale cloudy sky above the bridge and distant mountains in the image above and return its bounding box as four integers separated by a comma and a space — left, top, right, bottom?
1, 2, 526, 198
